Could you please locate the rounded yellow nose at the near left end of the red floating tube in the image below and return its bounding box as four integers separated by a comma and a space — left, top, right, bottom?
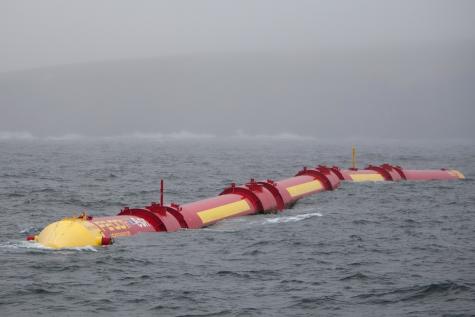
35, 218, 102, 249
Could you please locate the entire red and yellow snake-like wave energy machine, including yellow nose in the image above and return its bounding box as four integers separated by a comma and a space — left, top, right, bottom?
27, 164, 464, 248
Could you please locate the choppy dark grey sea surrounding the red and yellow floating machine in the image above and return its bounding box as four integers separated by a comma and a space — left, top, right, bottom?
0, 139, 475, 316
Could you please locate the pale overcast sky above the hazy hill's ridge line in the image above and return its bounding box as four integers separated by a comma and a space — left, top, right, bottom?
0, 0, 475, 71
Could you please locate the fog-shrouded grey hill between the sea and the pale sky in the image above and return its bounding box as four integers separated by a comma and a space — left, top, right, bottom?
0, 48, 475, 139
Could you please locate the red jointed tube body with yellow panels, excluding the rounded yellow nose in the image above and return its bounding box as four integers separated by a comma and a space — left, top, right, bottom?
107, 164, 463, 237
